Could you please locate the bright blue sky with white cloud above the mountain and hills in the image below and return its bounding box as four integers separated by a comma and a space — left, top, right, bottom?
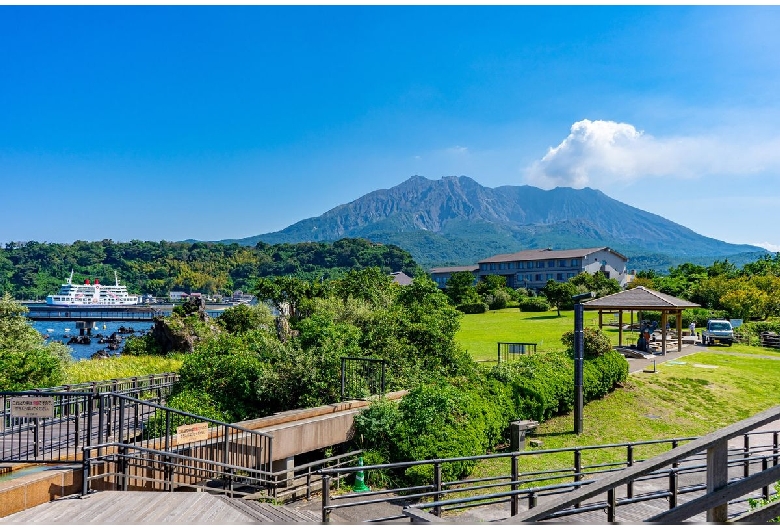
0, 6, 780, 251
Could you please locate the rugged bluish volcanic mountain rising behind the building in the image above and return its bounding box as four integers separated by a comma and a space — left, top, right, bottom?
225, 176, 766, 268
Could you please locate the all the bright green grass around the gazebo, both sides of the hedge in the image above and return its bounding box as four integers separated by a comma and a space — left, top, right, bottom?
457, 309, 780, 484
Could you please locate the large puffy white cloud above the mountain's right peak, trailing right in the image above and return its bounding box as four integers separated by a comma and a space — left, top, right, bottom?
526, 120, 780, 189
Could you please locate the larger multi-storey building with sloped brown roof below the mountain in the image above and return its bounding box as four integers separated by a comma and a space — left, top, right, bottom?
477, 247, 630, 290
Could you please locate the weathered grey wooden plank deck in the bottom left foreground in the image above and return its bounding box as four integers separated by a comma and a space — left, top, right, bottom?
0, 491, 320, 525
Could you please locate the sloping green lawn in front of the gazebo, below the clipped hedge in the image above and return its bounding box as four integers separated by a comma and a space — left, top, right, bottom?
464, 334, 780, 486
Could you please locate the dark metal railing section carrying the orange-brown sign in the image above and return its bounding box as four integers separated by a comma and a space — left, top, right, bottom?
82, 394, 273, 491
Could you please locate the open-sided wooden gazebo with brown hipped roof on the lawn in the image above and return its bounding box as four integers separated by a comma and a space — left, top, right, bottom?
583, 287, 700, 354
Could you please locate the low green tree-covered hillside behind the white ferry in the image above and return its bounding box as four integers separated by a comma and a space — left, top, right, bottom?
0, 239, 417, 300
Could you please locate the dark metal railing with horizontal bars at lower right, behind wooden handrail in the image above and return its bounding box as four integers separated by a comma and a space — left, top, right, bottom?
322, 422, 780, 522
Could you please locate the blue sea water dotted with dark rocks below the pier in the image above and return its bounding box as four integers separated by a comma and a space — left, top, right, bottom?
32, 321, 152, 361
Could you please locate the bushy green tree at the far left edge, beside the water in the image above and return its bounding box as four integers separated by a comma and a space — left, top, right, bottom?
0, 293, 70, 390
